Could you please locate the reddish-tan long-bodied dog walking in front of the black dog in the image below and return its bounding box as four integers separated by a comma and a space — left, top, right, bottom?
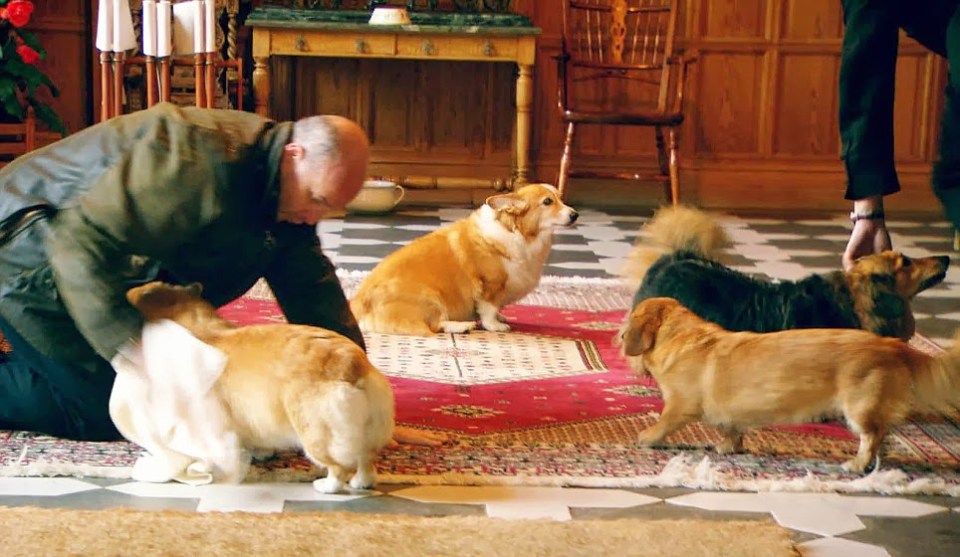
620, 298, 960, 472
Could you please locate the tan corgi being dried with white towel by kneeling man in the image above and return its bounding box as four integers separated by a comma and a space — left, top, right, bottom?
127, 282, 394, 493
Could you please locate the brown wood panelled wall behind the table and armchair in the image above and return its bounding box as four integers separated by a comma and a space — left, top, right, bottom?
273, 0, 945, 211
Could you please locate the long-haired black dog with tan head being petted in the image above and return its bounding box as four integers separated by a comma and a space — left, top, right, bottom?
623, 207, 950, 340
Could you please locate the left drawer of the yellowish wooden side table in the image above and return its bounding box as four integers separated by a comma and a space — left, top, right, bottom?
270, 31, 397, 57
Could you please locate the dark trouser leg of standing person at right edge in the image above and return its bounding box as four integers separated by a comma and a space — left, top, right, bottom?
931, 4, 960, 228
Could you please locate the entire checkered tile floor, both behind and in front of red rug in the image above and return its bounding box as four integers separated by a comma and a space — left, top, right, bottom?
0, 208, 960, 557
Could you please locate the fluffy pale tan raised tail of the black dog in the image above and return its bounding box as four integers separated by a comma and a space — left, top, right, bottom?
620, 206, 730, 291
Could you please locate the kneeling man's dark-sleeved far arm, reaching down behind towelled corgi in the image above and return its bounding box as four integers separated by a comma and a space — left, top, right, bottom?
265, 224, 366, 349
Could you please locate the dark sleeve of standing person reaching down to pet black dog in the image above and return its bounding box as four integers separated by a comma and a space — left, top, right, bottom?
839, 0, 900, 200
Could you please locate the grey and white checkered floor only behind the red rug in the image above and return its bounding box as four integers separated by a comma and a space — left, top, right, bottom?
319, 207, 960, 346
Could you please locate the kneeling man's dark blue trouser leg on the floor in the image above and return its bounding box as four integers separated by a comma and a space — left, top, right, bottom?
0, 319, 121, 441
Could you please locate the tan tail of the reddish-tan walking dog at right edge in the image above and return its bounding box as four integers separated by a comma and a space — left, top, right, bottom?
913, 329, 960, 419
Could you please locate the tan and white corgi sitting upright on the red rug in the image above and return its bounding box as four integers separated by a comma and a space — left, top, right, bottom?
350, 184, 577, 336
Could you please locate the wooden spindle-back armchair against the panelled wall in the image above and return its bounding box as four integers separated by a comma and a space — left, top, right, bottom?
557, 0, 694, 204
